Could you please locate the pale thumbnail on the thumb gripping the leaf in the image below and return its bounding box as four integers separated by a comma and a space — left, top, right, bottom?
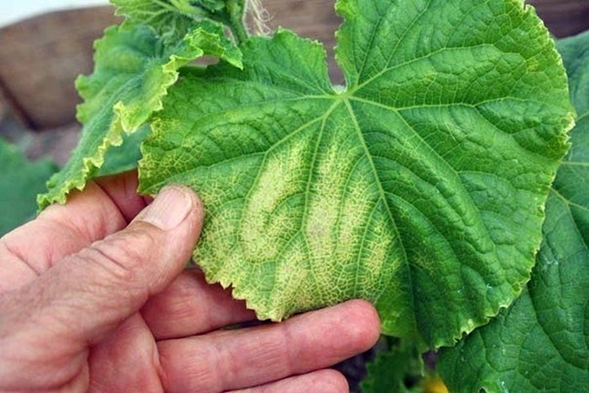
139, 186, 193, 231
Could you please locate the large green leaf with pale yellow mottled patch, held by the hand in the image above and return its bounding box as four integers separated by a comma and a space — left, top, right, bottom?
140, 0, 573, 347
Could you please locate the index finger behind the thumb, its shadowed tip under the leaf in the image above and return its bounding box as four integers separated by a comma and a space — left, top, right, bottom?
0, 171, 146, 293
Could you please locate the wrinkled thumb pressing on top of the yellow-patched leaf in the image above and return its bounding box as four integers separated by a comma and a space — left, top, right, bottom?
3, 186, 204, 350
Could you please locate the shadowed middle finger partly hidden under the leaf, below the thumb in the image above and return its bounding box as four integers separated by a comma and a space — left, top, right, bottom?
141, 269, 255, 340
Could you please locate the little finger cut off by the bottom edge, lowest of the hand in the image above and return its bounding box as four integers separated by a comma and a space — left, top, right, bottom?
233, 369, 349, 393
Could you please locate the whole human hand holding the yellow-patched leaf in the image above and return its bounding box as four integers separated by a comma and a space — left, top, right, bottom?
0, 172, 379, 392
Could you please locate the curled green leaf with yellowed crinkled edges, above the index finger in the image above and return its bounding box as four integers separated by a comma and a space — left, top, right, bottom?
38, 22, 241, 208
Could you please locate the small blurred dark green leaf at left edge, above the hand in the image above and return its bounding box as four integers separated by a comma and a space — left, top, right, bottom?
0, 138, 58, 236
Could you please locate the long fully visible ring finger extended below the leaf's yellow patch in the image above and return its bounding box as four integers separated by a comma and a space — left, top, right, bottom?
158, 300, 380, 392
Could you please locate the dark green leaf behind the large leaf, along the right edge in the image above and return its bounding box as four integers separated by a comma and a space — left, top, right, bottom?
438, 33, 589, 392
